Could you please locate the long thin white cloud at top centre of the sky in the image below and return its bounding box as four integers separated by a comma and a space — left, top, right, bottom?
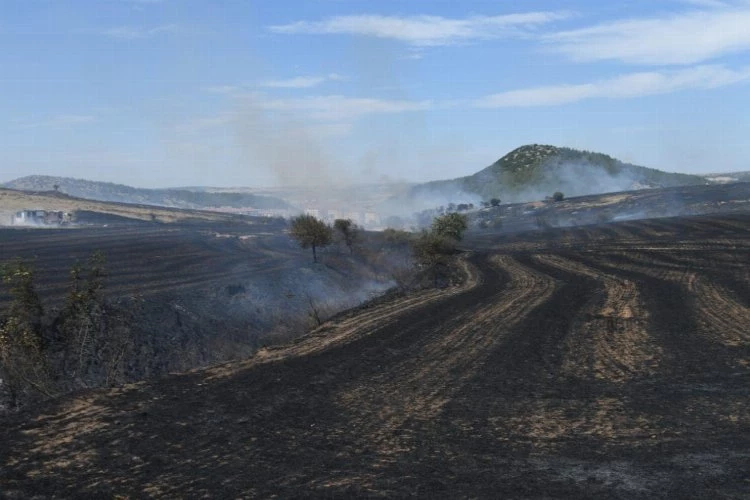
269, 12, 568, 46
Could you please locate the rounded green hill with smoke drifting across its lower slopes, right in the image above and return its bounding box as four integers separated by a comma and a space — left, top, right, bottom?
411, 144, 707, 201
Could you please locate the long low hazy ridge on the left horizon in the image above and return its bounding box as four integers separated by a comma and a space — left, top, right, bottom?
4, 175, 290, 209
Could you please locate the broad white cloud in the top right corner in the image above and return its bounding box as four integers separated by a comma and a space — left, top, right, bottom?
544, 2, 750, 65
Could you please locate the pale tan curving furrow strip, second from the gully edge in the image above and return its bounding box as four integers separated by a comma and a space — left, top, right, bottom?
339, 255, 555, 456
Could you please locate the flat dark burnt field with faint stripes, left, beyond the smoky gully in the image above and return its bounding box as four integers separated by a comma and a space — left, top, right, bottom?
0, 222, 294, 302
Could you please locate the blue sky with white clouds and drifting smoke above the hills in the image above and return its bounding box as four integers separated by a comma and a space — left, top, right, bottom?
0, 0, 750, 187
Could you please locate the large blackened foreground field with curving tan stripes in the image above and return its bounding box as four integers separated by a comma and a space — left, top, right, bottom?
0, 209, 750, 498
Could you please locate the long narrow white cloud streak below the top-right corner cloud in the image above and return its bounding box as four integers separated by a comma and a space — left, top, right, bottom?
471, 65, 750, 108
